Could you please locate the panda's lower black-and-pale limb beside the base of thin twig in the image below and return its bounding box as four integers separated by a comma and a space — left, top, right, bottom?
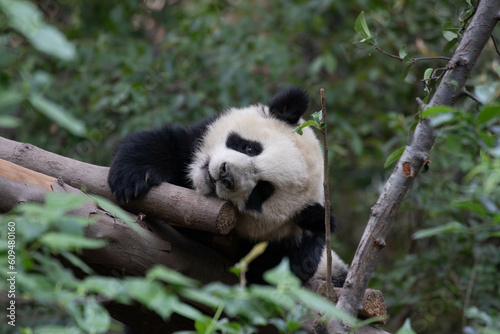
289, 231, 348, 287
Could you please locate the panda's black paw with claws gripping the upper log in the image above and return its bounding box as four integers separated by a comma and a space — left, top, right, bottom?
108, 168, 162, 204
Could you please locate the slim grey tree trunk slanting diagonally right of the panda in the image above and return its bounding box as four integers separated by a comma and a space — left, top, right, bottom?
328, 0, 500, 333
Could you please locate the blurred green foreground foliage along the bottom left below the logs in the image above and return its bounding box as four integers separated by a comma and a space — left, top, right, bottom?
0, 193, 356, 333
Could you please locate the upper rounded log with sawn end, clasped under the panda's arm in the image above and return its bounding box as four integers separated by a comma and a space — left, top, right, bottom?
0, 137, 237, 234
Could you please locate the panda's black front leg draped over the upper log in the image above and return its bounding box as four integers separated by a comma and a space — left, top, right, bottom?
108, 126, 191, 204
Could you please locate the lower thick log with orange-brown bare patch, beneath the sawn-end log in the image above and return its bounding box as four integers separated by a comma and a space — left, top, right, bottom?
0, 159, 238, 284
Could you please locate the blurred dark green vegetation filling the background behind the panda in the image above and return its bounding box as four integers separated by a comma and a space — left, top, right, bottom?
0, 0, 500, 334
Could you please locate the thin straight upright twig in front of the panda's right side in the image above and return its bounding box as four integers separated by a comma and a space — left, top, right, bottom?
319, 88, 333, 298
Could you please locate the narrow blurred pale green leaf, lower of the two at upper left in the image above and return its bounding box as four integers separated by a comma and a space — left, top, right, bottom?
29, 94, 86, 137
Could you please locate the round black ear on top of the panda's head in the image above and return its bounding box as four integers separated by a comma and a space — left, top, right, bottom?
267, 87, 309, 125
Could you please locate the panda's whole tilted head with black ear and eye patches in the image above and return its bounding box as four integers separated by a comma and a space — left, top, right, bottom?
189, 88, 324, 240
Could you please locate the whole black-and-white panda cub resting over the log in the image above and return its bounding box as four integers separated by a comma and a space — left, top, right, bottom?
108, 87, 347, 286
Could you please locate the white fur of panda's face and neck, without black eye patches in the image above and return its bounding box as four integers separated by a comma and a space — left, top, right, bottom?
189, 104, 324, 241
